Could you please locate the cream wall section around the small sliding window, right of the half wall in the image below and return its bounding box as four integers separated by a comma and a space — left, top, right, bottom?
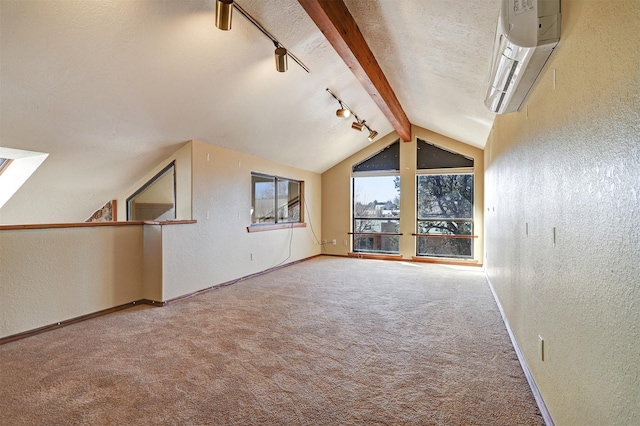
162, 141, 322, 300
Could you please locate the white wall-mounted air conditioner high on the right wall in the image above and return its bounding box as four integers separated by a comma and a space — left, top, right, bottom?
484, 0, 561, 114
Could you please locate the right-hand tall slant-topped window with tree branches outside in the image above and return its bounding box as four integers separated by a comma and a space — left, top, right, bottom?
416, 140, 474, 258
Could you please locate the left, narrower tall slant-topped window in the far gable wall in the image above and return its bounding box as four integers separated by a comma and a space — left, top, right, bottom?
352, 142, 400, 254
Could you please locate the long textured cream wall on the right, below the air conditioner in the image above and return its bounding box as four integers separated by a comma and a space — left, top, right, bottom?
485, 0, 640, 425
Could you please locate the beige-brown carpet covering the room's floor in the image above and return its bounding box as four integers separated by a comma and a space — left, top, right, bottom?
0, 257, 544, 426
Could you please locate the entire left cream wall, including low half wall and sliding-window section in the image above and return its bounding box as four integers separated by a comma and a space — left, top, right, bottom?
0, 142, 322, 338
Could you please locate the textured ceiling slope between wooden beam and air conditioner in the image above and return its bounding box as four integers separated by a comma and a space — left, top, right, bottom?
345, 0, 500, 148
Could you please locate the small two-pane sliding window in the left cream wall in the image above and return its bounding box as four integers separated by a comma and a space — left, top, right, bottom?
251, 173, 303, 225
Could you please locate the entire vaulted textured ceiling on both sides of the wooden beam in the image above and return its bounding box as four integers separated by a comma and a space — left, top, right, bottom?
0, 0, 498, 223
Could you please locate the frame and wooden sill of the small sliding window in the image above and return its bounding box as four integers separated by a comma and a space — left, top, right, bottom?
247, 172, 306, 232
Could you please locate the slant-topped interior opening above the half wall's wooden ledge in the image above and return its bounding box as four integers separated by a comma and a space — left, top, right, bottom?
127, 162, 176, 221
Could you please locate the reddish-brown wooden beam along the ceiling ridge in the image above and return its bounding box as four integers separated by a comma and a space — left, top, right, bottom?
298, 0, 411, 142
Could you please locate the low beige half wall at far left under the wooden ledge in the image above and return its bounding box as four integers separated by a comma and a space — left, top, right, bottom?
0, 226, 143, 337
